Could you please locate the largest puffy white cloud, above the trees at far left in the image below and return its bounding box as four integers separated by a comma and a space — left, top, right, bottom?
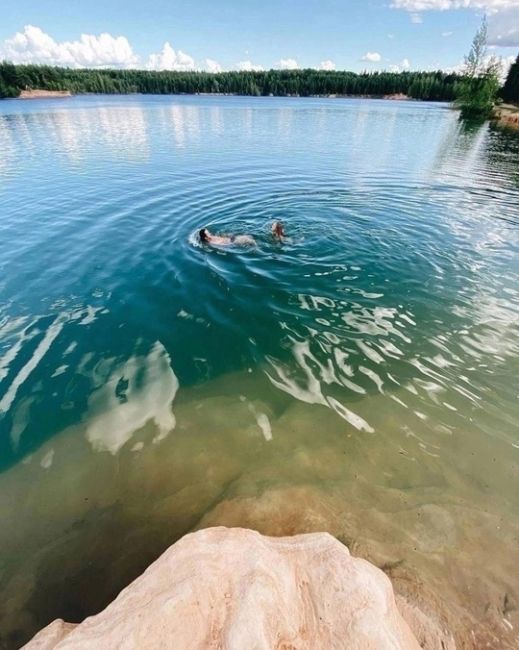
0, 25, 139, 68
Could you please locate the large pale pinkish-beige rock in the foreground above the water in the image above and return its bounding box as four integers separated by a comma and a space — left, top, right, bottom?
25, 528, 426, 650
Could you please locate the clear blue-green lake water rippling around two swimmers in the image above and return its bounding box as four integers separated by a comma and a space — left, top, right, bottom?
0, 96, 519, 647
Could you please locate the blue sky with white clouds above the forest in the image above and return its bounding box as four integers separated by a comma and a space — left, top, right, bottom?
0, 0, 519, 72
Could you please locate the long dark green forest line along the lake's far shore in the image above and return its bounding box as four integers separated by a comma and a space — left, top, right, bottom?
0, 62, 463, 101
